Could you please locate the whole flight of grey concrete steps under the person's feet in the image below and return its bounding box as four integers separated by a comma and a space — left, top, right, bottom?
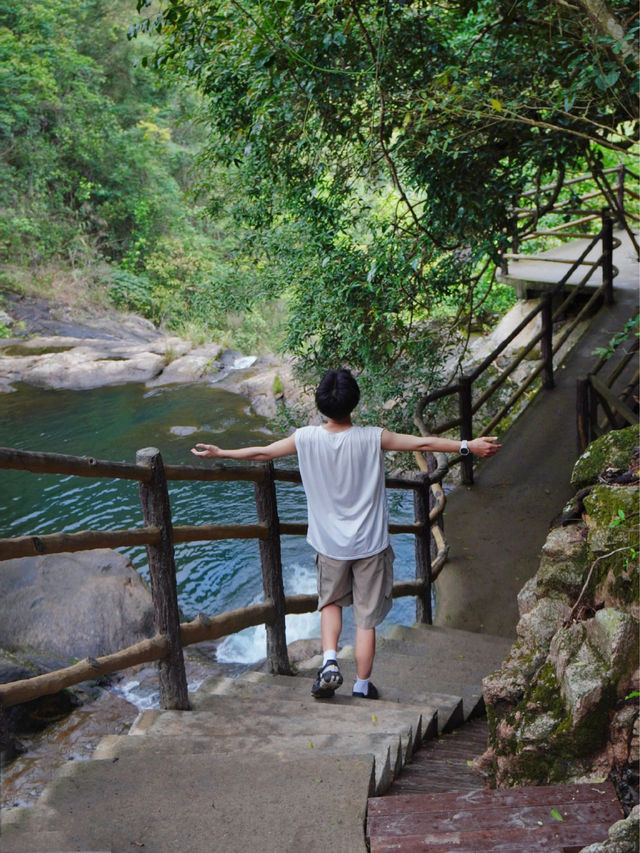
0, 626, 510, 853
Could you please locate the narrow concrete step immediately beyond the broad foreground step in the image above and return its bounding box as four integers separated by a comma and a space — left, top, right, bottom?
93, 731, 400, 797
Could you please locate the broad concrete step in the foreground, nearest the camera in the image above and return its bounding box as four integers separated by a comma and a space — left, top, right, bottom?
2, 752, 373, 853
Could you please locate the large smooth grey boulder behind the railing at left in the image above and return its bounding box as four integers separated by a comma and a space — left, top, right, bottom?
0, 549, 154, 659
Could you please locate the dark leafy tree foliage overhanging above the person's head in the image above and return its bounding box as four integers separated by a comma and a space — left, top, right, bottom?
132, 0, 637, 410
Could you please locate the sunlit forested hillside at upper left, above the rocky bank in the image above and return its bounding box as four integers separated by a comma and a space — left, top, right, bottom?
0, 0, 279, 347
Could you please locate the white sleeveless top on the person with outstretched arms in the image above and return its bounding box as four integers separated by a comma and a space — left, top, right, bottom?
294, 426, 389, 560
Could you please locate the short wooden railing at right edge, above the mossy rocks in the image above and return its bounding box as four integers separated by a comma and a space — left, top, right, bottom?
576, 317, 639, 455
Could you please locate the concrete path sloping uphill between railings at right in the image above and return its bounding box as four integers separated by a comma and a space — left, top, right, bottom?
435, 232, 639, 637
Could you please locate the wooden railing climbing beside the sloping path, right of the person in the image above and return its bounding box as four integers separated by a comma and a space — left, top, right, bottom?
415, 211, 617, 485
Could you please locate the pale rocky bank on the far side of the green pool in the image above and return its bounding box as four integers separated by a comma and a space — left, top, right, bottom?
0, 292, 303, 417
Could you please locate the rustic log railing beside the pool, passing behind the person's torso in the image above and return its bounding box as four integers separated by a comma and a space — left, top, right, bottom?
0, 448, 448, 708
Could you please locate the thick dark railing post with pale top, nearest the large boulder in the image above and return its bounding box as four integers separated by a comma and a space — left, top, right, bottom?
136, 447, 190, 711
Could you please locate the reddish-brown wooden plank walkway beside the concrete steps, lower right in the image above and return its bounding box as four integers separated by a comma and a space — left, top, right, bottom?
367, 717, 623, 853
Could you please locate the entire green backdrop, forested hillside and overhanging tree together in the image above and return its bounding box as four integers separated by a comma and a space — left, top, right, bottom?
0, 0, 639, 421
